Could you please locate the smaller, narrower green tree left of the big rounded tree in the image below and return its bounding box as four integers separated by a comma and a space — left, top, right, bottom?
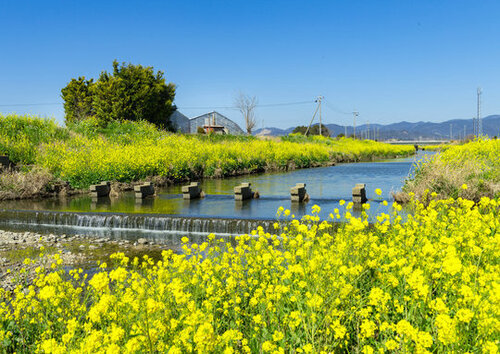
61, 76, 94, 123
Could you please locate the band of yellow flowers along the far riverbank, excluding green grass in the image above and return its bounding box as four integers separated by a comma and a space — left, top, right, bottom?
38, 134, 412, 187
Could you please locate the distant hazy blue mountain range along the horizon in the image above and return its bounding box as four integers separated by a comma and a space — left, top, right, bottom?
254, 115, 500, 140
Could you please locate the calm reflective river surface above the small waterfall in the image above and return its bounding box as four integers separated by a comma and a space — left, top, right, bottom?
0, 152, 429, 219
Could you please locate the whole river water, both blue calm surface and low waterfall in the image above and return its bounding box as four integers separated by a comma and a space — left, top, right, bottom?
0, 152, 430, 242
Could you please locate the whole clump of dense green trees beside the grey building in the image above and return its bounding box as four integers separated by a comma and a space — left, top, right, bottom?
62, 60, 176, 129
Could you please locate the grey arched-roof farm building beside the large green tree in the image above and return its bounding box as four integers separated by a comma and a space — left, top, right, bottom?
170, 111, 245, 135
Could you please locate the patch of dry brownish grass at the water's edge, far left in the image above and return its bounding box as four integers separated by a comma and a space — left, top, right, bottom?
0, 167, 56, 200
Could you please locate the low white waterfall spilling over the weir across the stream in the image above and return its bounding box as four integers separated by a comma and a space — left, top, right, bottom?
0, 210, 274, 235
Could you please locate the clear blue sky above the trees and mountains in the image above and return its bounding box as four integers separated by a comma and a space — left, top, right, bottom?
0, 0, 500, 128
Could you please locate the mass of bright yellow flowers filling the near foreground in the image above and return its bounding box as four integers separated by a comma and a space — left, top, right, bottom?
0, 198, 500, 353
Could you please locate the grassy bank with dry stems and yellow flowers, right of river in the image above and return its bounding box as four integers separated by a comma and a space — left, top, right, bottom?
403, 140, 500, 201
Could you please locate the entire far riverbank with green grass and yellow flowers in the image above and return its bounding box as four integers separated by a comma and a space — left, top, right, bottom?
0, 116, 413, 188
